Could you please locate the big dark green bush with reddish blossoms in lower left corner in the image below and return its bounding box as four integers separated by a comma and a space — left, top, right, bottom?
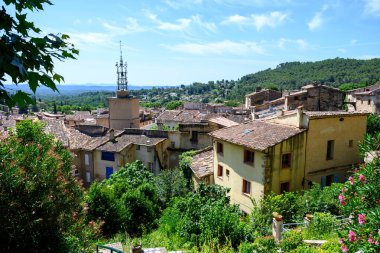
0, 120, 97, 252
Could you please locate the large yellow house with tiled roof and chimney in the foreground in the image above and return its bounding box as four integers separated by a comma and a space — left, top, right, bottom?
211, 108, 367, 213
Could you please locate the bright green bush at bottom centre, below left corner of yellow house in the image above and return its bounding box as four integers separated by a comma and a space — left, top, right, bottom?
160, 184, 246, 247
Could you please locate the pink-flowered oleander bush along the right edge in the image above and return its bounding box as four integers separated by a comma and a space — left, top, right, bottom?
339, 135, 380, 252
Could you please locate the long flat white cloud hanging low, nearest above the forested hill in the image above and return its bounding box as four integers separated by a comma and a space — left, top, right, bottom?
163, 40, 264, 55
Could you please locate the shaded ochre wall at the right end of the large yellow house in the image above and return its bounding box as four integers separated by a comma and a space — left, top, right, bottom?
305, 116, 367, 182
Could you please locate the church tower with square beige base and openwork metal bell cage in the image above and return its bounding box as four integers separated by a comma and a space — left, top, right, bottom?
108, 42, 140, 130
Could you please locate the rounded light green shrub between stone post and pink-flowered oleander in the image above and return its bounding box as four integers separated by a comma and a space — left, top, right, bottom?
306, 213, 339, 240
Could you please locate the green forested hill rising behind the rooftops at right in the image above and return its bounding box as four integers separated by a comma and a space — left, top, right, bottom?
228, 58, 380, 100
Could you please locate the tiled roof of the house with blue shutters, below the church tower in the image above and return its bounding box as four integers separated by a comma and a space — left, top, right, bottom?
97, 134, 166, 152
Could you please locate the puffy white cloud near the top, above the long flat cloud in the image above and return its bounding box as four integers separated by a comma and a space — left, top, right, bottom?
222, 11, 288, 31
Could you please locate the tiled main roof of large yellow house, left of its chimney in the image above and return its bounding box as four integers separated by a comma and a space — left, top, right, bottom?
210, 120, 305, 151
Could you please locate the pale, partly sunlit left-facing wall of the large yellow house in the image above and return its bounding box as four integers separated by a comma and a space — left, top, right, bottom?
214, 141, 265, 213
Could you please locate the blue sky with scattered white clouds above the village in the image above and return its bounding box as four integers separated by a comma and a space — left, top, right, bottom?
19, 0, 380, 85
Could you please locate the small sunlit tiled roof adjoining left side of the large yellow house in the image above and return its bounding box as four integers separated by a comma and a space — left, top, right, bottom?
190, 148, 214, 178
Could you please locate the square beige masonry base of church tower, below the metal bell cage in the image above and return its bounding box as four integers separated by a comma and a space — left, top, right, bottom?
108, 98, 140, 129
